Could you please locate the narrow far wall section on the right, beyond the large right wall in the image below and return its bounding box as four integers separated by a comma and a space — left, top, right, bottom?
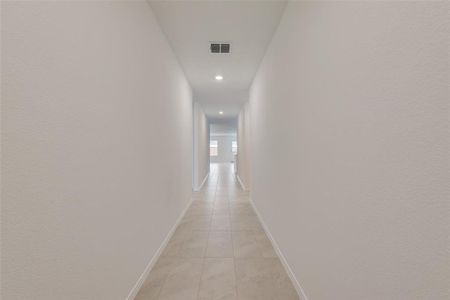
236, 102, 251, 190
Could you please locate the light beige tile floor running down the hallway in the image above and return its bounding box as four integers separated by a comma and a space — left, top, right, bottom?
136, 164, 299, 300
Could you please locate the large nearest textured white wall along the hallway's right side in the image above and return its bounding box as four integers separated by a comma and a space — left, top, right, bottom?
250, 1, 450, 300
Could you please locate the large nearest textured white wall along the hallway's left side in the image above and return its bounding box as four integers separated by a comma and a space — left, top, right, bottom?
0, 1, 192, 300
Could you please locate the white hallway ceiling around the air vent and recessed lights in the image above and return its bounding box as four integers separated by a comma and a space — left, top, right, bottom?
150, 1, 286, 120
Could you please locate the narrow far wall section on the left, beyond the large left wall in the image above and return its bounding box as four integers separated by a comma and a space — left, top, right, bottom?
193, 102, 209, 190
